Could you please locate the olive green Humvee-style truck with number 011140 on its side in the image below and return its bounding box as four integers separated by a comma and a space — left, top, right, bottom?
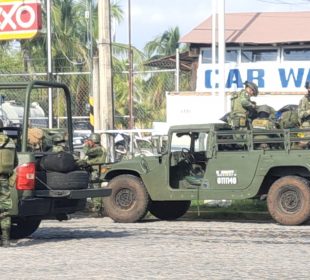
104, 123, 310, 225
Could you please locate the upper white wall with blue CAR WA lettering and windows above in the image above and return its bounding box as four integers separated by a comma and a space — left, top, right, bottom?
196, 45, 310, 94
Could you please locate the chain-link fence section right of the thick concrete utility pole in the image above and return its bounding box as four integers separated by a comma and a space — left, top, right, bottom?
113, 66, 191, 128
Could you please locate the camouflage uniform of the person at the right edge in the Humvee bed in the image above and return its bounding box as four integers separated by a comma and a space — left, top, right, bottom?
298, 81, 310, 148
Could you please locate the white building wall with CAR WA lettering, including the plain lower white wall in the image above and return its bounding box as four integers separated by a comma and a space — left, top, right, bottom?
167, 44, 310, 125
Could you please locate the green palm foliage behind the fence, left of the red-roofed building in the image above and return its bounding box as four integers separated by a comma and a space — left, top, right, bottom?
0, 0, 188, 128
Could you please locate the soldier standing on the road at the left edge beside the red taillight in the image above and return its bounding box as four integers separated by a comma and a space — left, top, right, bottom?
0, 132, 16, 247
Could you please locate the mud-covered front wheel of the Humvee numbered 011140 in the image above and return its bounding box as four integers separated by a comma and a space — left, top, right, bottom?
103, 175, 149, 223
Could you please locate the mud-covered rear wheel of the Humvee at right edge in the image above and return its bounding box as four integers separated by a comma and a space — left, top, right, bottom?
267, 176, 310, 225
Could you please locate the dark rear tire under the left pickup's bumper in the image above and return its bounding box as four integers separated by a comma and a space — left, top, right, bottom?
11, 217, 41, 239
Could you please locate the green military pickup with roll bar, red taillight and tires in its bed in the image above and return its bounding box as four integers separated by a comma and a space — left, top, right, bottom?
0, 81, 111, 239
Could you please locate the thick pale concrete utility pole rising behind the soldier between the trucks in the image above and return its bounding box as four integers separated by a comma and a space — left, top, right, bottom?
94, 0, 114, 130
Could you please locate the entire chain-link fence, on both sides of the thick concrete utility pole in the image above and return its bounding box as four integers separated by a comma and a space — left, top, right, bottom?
0, 58, 190, 129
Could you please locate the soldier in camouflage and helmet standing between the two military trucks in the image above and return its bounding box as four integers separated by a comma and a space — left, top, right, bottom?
83, 133, 107, 215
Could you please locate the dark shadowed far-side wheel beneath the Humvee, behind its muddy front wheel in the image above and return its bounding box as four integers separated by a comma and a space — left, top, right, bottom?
149, 200, 191, 220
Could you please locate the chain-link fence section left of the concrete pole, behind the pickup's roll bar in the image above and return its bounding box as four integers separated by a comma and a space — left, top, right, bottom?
0, 70, 90, 129
